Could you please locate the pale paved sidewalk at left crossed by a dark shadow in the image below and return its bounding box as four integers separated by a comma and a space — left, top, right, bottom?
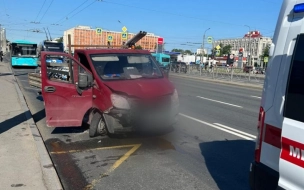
0, 59, 62, 190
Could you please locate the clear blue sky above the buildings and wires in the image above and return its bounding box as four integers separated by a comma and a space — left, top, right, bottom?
0, 0, 283, 51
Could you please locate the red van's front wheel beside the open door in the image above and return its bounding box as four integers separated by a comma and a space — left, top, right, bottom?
89, 112, 107, 137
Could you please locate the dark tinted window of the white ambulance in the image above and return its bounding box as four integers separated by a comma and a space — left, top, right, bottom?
284, 34, 304, 122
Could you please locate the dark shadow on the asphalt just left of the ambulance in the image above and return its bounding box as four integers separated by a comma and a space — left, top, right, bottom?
199, 140, 255, 189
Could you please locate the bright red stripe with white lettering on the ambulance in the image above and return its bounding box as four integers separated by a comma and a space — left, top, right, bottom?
281, 137, 304, 168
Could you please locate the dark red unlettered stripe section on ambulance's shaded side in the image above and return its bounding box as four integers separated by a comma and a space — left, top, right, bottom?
264, 124, 282, 149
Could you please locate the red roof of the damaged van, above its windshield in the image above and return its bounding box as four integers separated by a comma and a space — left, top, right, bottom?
74, 49, 151, 54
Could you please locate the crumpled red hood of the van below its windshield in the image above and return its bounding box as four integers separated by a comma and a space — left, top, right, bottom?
104, 78, 175, 99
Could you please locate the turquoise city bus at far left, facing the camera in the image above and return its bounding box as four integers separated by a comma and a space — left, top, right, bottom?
11, 40, 38, 67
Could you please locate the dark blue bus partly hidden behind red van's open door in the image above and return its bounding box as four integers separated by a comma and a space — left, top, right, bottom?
37, 40, 64, 63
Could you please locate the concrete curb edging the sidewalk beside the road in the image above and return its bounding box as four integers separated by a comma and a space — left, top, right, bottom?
9, 64, 63, 190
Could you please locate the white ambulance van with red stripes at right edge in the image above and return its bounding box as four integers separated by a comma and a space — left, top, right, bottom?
250, 0, 304, 190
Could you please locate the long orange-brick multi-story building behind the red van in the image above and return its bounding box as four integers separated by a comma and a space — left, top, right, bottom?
63, 26, 159, 51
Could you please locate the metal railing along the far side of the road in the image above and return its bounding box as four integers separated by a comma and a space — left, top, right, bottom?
169, 64, 265, 85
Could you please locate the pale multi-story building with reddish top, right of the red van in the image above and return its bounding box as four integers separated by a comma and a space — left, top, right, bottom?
214, 31, 272, 65
